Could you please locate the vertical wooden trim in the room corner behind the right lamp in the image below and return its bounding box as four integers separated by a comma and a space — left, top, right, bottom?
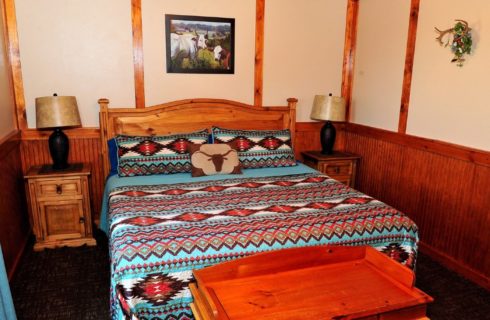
341, 0, 359, 122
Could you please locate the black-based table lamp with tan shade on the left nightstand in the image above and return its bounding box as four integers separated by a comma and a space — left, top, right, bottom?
36, 93, 81, 170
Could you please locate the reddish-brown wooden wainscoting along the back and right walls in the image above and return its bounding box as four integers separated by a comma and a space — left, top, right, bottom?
14, 122, 490, 288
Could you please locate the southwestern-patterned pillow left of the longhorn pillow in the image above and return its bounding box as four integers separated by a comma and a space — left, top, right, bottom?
116, 130, 208, 177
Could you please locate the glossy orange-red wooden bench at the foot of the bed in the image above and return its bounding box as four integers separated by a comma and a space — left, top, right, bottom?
190, 246, 433, 320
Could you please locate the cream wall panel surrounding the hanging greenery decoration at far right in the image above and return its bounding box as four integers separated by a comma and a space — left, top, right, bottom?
408, 0, 490, 150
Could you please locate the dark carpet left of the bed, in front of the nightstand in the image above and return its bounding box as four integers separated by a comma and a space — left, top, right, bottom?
10, 232, 109, 320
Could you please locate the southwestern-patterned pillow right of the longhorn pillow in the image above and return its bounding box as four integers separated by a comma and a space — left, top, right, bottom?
212, 127, 296, 169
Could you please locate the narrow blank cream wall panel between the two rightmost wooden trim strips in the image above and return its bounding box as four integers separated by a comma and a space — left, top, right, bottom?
351, 0, 410, 131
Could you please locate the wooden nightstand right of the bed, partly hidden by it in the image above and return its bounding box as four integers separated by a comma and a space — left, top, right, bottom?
301, 151, 361, 188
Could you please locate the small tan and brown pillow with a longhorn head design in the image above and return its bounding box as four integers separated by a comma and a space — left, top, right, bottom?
189, 143, 242, 177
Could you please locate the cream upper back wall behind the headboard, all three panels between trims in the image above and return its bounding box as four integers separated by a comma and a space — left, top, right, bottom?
16, 0, 347, 127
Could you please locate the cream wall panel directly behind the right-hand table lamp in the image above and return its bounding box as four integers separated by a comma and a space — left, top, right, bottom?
263, 0, 347, 121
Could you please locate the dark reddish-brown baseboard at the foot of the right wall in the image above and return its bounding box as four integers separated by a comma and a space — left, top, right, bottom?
419, 242, 490, 291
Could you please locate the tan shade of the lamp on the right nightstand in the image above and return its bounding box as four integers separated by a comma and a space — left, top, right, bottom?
310, 95, 345, 121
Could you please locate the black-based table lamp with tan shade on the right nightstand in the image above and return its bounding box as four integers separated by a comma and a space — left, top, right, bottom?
310, 93, 345, 154
